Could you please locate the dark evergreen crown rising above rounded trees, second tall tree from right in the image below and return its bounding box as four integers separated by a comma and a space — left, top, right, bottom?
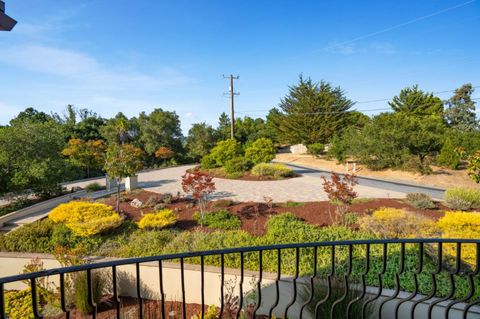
388, 85, 443, 115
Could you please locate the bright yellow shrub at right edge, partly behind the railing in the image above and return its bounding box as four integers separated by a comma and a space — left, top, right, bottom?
437, 211, 480, 265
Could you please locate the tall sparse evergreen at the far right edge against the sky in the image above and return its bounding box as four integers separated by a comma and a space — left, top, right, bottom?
445, 83, 479, 131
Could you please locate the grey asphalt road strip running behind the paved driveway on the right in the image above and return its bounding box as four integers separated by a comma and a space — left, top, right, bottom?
284, 163, 445, 199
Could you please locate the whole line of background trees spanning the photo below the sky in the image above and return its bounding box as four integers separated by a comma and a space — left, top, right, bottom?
0, 76, 480, 197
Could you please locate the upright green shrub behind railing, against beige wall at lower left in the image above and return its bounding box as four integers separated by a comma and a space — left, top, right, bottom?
73, 271, 106, 314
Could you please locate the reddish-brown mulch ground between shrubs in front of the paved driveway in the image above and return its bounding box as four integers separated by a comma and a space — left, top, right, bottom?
98, 190, 447, 235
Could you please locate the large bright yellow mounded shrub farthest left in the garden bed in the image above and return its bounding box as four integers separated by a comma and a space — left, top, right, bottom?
48, 202, 123, 237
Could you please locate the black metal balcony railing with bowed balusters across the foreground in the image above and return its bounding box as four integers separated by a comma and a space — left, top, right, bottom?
0, 239, 480, 319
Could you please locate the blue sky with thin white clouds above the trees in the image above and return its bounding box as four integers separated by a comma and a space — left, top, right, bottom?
0, 0, 480, 131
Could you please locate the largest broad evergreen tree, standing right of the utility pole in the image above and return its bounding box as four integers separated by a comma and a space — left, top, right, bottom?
272, 75, 354, 144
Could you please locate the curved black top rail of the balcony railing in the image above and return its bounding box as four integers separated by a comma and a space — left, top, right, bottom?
0, 238, 480, 284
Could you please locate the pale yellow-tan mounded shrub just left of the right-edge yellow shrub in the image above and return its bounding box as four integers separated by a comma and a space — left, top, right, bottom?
360, 207, 436, 238
